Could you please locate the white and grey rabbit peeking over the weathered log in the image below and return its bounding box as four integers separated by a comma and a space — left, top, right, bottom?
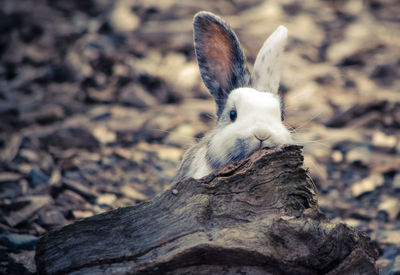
174, 11, 292, 181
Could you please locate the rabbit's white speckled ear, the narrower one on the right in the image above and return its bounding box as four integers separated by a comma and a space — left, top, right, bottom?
252, 26, 288, 93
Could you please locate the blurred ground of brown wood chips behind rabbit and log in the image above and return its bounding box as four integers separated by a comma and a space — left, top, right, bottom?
0, 0, 400, 274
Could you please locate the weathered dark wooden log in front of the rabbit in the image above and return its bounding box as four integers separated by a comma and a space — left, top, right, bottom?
36, 146, 378, 274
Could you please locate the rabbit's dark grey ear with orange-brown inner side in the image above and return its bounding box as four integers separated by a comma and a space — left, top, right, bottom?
194, 11, 250, 117
